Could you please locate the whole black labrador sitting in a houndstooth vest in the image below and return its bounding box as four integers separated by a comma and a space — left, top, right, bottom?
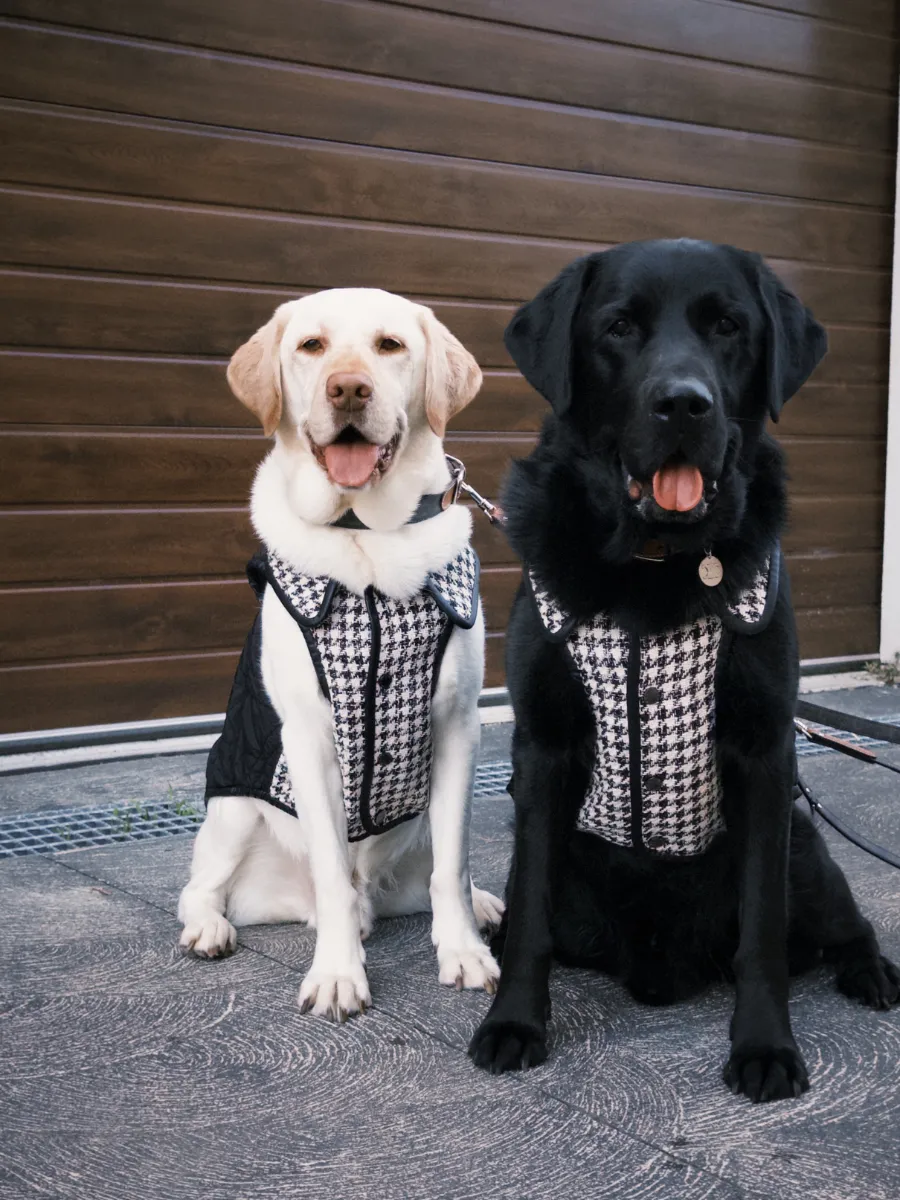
469, 240, 900, 1100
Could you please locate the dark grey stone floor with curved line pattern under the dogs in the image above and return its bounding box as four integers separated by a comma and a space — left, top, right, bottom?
0, 728, 900, 1200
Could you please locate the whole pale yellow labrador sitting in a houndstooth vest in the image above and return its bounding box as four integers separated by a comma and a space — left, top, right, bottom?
179, 288, 503, 1019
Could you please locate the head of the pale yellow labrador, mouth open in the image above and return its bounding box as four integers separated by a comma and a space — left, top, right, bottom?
228, 288, 481, 492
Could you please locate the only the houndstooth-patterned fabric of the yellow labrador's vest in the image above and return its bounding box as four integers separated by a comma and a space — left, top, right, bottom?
270, 547, 478, 841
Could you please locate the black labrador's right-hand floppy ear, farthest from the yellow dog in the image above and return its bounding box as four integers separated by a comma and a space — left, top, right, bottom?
758, 259, 828, 421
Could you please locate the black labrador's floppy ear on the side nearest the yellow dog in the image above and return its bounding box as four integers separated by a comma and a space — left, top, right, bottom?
503, 254, 600, 416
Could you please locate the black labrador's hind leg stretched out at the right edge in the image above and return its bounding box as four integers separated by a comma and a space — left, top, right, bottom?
790, 808, 900, 1008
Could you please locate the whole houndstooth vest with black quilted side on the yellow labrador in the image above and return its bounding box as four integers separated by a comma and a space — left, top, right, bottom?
206, 546, 479, 841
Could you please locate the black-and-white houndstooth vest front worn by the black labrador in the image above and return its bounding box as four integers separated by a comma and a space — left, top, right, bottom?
527, 550, 780, 856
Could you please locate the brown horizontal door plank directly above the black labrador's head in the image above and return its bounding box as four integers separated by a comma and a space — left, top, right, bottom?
0, 104, 893, 266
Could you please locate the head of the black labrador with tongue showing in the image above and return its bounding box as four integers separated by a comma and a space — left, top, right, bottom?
506, 240, 826, 548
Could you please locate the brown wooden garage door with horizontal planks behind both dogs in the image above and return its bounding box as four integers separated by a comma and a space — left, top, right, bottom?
0, 0, 896, 730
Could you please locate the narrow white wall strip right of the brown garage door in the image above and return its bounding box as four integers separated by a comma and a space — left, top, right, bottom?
880, 85, 900, 662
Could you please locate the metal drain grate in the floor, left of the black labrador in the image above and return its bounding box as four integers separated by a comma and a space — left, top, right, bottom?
0, 762, 512, 858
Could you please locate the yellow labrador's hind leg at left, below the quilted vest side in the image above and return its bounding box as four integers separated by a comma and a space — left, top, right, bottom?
178, 796, 259, 959
